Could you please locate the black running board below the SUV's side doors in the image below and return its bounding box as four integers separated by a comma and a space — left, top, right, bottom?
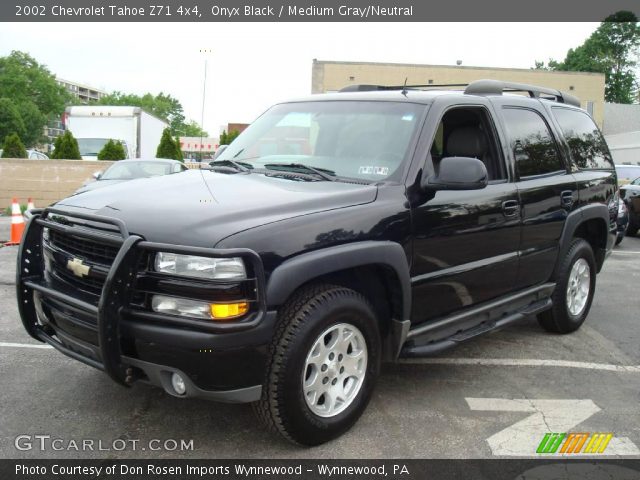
400, 283, 555, 358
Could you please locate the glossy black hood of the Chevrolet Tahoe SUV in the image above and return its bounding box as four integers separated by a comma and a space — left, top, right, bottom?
56, 170, 377, 247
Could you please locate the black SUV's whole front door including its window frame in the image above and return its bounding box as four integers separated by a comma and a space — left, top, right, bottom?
411, 98, 520, 324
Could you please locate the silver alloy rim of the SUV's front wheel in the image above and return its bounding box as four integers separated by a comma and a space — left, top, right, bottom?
302, 323, 367, 418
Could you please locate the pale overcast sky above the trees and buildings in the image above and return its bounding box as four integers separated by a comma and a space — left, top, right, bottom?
0, 22, 598, 135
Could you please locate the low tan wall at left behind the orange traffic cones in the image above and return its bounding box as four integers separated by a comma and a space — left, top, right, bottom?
0, 158, 113, 209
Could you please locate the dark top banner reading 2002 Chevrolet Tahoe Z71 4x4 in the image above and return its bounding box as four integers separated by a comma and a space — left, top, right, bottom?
0, 0, 640, 22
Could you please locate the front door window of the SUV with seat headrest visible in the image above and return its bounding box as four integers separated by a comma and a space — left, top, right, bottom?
430, 107, 507, 182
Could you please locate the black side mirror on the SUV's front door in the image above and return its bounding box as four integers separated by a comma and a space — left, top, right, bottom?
422, 157, 489, 190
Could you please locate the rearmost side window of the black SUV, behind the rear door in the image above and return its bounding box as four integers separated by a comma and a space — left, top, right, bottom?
553, 108, 613, 170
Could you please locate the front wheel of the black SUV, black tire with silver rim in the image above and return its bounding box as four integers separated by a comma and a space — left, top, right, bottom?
253, 285, 381, 446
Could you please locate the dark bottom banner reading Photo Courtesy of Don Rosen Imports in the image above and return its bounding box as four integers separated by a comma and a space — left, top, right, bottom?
0, 458, 640, 480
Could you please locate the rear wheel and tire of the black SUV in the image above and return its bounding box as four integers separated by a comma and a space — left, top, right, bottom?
538, 238, 596, 333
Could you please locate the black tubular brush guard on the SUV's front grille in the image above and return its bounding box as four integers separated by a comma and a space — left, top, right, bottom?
16, 208, 266, 386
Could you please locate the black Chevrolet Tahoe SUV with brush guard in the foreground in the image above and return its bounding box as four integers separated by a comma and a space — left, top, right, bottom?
17, 80, 618, 445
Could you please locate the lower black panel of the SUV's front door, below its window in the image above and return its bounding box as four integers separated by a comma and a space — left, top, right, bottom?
411, 183, 520, 323
